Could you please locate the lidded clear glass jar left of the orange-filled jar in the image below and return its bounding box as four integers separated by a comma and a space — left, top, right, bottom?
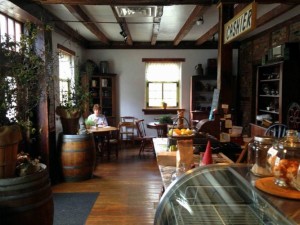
248, 136, 274, 177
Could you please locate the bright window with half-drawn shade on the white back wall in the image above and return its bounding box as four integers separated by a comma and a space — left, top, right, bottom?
145, 61, 182, 108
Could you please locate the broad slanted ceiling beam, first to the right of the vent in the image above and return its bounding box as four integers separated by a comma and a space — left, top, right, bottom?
174, 5, 208, 45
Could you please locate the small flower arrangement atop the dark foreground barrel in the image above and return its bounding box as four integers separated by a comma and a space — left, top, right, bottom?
16, 152, 41, 177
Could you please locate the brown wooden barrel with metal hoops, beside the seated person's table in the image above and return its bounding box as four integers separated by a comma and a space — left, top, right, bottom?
61, 134, 96, 182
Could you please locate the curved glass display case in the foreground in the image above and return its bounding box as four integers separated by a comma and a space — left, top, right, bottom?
154, 164, 300, 225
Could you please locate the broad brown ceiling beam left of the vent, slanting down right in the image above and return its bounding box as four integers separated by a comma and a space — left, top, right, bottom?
64, 5, 109, 44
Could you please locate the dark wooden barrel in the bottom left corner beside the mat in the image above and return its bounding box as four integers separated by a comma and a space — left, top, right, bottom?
0, 165, 54, 225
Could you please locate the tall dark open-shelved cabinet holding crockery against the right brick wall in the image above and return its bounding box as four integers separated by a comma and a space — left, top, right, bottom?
255, 61, 300, 125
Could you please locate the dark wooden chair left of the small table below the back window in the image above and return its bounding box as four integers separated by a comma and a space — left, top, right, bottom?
135, 119, 155, 156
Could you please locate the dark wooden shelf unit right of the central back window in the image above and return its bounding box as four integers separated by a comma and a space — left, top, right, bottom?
190, 75, 217, 120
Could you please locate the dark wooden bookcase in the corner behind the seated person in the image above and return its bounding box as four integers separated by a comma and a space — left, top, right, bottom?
88, 74, 116, 126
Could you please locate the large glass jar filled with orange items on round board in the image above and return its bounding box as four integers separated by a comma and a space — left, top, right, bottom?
268, 130, 300, 190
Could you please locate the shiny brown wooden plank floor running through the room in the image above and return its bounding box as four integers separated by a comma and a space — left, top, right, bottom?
52, 146, 162, 225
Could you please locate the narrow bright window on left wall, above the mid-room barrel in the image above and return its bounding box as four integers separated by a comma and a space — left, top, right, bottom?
58, 46, 75, 105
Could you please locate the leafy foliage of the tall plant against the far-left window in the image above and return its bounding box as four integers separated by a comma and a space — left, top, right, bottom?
0, 23, 49, 176
